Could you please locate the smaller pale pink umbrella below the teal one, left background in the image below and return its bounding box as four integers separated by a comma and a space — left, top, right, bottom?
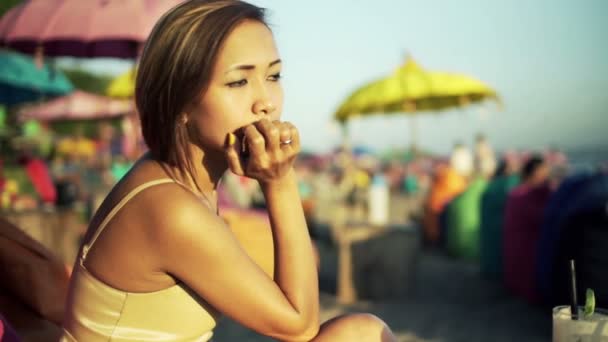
18, 90, 134, 121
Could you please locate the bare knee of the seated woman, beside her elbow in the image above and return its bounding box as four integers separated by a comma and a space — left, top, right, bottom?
313, 313, 396, 342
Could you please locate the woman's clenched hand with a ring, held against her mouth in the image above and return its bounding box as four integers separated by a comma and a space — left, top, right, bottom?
226, 119, 300, 185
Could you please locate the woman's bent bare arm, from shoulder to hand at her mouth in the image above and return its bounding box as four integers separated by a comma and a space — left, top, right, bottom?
150, 122, 319, 341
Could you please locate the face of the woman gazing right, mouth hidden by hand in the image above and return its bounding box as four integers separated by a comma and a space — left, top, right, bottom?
186, 21, 283, 150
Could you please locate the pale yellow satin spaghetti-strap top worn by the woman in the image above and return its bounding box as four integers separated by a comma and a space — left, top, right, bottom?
61, 179, 218, 342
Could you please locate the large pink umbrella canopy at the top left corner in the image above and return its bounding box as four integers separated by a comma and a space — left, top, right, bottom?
0, 0, 183, 58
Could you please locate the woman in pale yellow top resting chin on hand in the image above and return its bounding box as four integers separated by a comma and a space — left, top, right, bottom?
64, 0, 394, 341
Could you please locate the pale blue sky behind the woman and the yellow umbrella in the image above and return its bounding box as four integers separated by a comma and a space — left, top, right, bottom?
70, 0, 608, 153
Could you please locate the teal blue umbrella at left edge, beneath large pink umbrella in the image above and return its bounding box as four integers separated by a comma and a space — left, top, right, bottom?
0, 50, 74, 106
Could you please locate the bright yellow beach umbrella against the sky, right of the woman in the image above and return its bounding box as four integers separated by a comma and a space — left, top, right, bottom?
334, 57, 500, 146
